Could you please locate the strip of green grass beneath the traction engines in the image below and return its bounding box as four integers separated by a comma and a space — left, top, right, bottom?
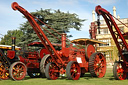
0, 68, 128, 85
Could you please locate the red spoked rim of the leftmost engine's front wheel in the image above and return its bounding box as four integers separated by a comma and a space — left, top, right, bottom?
12, 63, 26, 80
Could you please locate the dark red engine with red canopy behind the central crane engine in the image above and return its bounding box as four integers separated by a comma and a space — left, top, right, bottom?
19, 42, 49, 78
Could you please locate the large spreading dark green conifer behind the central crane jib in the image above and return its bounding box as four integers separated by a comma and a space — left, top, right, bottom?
19, 9, 85, 45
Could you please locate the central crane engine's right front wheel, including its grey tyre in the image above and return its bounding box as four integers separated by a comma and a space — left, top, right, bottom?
66, 61, 81, 80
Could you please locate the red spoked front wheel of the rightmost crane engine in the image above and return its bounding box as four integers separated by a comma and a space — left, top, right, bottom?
113, 62, 127, 80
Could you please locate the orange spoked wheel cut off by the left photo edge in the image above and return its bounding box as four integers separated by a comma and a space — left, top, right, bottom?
0, 61, 9, 80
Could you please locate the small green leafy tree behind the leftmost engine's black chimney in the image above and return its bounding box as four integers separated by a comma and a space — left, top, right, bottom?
0, 30, 23, 45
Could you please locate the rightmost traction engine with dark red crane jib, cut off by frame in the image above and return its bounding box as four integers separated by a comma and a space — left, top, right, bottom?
95, 6, 128, 80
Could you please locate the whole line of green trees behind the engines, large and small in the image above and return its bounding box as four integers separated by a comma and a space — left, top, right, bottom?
0, 9, 85, 47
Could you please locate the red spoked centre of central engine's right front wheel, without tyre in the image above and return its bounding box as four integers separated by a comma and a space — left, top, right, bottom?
70, 62, 80, 80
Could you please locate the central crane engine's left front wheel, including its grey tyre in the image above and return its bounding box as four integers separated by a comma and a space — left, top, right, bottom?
45, 62, 60, 80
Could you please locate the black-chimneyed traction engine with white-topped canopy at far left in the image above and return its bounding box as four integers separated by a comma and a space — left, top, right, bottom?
0, 37, 27, 80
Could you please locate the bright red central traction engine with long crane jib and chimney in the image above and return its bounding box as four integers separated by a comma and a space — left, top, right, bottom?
12, 2, 106, 80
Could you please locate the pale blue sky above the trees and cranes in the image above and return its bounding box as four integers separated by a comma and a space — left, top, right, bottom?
0, 0, 128, 40
